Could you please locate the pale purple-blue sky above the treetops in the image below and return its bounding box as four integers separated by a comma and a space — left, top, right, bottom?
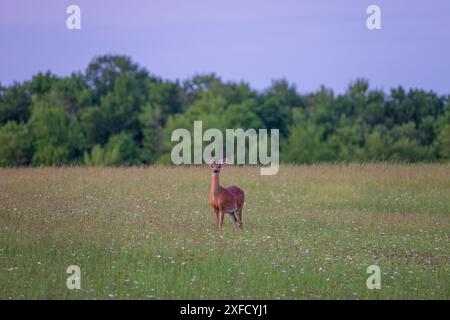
0, 0, 450, 94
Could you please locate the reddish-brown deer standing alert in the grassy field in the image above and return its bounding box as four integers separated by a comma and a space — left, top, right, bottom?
207, 158, 244, 231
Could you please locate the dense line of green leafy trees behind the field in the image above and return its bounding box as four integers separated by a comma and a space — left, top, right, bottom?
0, 55, 450, 166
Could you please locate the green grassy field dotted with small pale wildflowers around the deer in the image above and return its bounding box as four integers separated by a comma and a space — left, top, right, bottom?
0, 164, 450, 299
